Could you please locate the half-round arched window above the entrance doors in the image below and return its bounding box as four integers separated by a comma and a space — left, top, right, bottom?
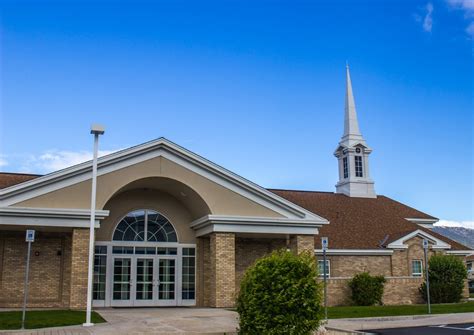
113, 209, 178, 242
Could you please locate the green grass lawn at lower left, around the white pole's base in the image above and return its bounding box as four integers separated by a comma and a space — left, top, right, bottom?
0, 310, 105, 330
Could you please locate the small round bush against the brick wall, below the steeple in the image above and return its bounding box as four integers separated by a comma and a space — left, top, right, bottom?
349, 272, 385, 306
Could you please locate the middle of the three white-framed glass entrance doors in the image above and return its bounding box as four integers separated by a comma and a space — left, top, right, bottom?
134, 257, 155, 306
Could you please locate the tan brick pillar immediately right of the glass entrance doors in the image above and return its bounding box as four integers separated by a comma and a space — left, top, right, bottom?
209, 233, 235, 307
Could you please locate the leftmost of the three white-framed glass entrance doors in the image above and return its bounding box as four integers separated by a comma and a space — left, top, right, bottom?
111, 257, 132, 306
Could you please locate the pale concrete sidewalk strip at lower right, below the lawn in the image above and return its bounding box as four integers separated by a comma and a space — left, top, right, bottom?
328, 313, 474, 331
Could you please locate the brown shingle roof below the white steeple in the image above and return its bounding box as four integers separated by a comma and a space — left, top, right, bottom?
269, 189, 469, 250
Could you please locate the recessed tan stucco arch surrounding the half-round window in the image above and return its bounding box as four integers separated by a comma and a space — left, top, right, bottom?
96, 190, 195, 243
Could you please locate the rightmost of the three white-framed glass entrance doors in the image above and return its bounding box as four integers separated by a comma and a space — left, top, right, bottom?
158, 257, 177, 306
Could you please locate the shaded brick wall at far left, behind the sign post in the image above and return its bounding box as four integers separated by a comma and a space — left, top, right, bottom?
0, 231, 70, 308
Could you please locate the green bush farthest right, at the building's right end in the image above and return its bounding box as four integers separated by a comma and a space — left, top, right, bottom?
420, 254, 467, 304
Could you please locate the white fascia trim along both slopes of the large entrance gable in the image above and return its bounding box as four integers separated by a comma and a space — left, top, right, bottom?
0, 138, 327, 222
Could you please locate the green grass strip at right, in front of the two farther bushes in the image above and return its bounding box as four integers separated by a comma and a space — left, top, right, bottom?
328, 301, 474, 319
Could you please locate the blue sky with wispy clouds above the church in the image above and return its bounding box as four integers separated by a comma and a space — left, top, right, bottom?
0, 0, 474, 224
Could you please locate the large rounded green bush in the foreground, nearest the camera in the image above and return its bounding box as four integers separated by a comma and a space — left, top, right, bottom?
237, 250, 322, 335
